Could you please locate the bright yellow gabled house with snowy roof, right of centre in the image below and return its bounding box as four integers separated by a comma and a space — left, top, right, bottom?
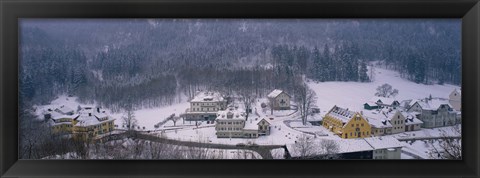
323, 106, 371, 138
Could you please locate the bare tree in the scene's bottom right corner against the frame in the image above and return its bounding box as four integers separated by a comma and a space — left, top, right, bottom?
430, 125, 462, 159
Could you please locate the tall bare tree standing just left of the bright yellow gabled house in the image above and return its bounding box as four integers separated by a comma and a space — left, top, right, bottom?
295, 84, 317, 125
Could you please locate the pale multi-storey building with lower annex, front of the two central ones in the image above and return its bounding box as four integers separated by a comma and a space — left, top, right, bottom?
215, 107, 270, 138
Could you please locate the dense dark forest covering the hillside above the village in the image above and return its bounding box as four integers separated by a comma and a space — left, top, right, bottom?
19, 19, 461, 110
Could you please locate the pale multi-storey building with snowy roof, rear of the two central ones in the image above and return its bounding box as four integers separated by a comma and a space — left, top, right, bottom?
182, 92, 227, 121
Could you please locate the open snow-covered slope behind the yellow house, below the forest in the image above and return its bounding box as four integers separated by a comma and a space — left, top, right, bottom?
308, 67, 460, 115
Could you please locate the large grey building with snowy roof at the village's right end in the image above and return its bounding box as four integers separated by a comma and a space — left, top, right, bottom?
408, 98, 461, 128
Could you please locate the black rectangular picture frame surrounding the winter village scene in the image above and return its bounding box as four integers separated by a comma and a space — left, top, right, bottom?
0, 0, 480, 177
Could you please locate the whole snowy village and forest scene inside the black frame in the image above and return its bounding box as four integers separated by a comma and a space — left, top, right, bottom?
19, 19, 462, 160
